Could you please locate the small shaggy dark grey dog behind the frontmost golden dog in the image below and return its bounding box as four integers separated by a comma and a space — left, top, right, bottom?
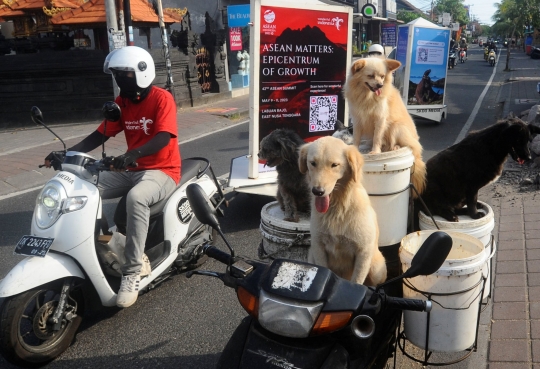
259, 129, 311, 222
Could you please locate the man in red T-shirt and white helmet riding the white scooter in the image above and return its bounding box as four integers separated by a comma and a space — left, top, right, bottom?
45, 46, 181, 307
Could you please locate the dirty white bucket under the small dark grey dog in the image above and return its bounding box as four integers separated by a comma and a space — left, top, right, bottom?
259, 201, 311, 261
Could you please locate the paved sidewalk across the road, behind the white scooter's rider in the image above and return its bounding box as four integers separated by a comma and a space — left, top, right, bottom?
0, 95, 249, 199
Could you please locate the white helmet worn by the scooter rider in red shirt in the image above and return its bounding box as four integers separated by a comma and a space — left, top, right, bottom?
103, 46, 156, 88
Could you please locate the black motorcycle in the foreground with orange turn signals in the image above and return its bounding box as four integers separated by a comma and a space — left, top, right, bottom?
187, 184, 452, 369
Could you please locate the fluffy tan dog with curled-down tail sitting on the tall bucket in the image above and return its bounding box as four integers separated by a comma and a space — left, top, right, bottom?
344, 58, 426, 196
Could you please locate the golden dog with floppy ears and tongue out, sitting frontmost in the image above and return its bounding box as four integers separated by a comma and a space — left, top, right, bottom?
298, 137, 386, 285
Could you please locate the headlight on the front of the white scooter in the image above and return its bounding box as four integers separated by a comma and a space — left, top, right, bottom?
35, 182, 67, 229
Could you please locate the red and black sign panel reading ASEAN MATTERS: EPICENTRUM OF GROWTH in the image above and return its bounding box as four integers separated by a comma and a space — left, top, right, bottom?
255, 6, 349, 141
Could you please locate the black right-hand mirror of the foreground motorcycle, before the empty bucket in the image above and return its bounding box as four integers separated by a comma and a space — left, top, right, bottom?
401, 232, 452, 278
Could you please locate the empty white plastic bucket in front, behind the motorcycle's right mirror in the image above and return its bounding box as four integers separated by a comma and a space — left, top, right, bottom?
399, 231, 489, 352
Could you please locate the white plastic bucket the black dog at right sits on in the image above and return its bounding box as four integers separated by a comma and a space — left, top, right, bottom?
418, 201, 496, 298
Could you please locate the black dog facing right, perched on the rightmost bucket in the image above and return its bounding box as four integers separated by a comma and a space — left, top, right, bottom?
415, 113, 540, 224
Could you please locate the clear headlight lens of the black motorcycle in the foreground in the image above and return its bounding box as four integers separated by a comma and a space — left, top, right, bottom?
259, 290, 323, 338
